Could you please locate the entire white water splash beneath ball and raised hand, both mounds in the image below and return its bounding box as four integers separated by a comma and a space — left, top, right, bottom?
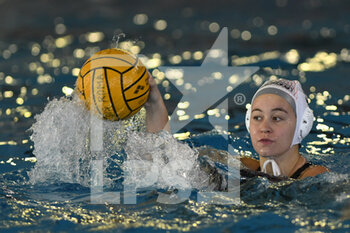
28, 94, 208, 189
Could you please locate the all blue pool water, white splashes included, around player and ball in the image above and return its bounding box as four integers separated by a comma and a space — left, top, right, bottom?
0, 0, 350, 232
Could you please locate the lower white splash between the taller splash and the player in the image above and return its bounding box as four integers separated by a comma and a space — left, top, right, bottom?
123, 131, 209, 189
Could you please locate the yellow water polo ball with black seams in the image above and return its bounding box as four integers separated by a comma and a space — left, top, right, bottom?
76, 49, 150, 121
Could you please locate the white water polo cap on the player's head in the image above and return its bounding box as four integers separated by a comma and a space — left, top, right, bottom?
245, 78, 314, 147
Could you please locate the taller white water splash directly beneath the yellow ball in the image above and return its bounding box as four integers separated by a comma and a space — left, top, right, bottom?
28, 97, 145, 186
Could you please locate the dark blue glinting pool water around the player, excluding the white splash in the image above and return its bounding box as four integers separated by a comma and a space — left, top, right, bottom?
0, 0, 350, 232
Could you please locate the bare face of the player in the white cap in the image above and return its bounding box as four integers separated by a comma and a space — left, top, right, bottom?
249, 94, 296, 157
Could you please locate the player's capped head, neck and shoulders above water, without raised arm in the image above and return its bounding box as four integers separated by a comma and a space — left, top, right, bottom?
241, 79, 328, 179
